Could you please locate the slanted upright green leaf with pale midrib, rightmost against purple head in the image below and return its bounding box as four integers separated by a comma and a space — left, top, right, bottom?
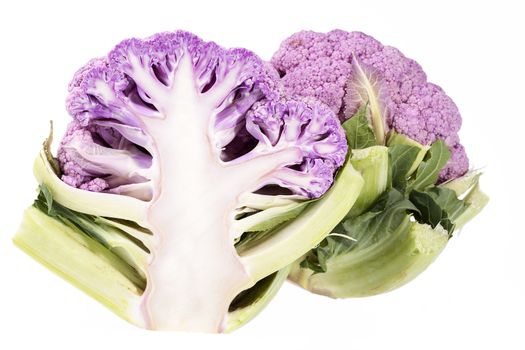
408, 140, 450, 192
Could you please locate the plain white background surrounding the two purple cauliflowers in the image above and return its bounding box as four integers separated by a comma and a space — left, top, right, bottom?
0, 0, 525, 350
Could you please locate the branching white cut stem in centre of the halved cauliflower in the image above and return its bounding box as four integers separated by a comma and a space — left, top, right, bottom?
123, 51, 301, 332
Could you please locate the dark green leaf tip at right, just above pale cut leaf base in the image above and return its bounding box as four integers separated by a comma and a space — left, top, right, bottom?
410, 191, 454, 236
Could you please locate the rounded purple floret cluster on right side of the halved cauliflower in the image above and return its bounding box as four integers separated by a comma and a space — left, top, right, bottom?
246, 99, 348, 198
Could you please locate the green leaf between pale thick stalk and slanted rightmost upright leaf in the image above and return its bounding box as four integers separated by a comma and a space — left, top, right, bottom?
388, 145, 420, 192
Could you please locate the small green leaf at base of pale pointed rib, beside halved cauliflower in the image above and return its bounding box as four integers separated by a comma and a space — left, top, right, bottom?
343, 104, 377, 149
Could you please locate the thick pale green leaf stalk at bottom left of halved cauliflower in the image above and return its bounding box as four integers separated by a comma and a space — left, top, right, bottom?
13, 207, 144, 327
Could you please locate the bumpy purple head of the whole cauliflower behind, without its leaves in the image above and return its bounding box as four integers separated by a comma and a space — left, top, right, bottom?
271, 30, 468, 181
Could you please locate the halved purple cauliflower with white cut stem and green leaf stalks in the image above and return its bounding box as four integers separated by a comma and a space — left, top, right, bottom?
15, 32, 363, 332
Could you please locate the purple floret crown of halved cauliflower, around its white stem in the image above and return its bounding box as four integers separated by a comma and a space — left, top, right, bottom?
59, 31, 347, 199
